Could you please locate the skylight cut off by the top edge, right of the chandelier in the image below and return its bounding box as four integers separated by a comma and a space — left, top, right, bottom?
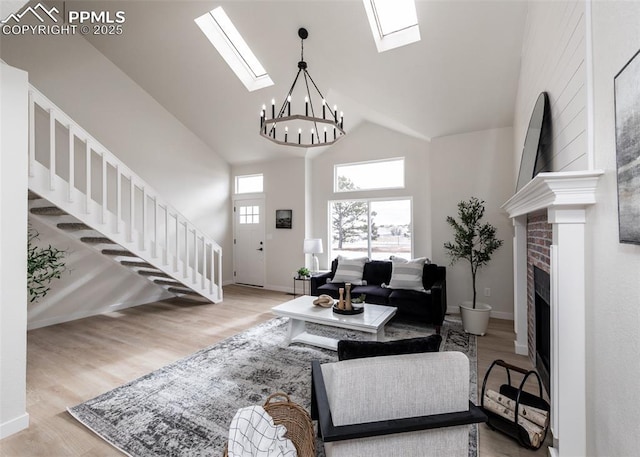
362, 0, 420, 52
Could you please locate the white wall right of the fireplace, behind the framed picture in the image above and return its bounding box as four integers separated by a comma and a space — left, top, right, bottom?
586, 1, 640, 457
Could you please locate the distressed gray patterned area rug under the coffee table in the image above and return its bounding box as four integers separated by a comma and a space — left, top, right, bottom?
68, 317, 477, 457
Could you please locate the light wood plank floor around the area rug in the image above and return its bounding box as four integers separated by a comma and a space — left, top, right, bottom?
0, 286, 545, 457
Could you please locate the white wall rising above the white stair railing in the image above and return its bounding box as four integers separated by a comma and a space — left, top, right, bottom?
0, 18, 232, 318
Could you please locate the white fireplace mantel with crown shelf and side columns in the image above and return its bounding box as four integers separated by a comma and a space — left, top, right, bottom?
502, 170, 604, 457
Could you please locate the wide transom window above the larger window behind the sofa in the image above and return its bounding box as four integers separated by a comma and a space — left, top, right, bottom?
333, 157, 404, 192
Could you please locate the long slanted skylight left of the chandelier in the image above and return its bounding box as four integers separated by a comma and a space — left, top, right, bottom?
195, 6, 273, 92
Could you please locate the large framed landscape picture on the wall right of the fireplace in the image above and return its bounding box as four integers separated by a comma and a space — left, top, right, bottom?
613, 51, 640, 244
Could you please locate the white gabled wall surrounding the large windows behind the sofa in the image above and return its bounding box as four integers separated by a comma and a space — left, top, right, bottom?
308, 123, 432, 269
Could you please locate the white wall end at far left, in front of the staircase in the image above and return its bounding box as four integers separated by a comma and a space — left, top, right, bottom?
0, 63, 29, 439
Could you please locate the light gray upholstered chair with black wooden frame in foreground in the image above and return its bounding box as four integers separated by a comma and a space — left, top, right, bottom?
311, 352, 486, 457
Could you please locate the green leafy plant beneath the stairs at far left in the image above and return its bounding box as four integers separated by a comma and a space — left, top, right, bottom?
27, 226, 67, 302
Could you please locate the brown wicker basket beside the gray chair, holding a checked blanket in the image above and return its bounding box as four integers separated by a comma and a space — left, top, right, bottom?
224, 392, 316, 457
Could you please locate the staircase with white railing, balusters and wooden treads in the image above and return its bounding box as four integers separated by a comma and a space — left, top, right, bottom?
29, 86, 222, 303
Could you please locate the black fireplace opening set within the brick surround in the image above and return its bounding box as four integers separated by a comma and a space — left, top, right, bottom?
533, 266, 551, 392
